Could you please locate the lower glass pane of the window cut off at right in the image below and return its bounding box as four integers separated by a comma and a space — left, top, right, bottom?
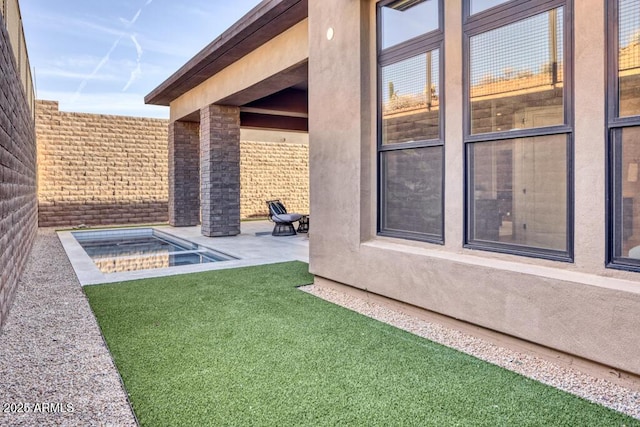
616, 127, 640, 259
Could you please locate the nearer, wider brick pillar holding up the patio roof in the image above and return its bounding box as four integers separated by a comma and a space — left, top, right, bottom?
200, 105, 240, 237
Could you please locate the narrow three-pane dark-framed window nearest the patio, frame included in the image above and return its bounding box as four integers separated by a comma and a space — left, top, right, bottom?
378, 0, 444, 243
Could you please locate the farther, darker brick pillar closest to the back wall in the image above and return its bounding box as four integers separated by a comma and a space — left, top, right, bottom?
169, 121, 200, 227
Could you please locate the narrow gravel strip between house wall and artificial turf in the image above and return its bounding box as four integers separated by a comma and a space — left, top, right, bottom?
300, 285, 640, 419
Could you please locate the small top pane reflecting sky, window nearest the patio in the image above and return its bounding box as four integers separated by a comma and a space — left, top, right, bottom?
381, 0, 439, 49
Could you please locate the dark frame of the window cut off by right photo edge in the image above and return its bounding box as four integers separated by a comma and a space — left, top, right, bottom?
605, 0, 640, 272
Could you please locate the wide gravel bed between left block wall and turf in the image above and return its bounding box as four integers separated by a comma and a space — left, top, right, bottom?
0, 229, 136, 426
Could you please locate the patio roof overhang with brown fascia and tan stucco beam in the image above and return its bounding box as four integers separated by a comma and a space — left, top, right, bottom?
145, 0, 308, 130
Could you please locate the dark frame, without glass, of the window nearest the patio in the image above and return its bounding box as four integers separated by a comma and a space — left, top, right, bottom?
376, 0, 446, 245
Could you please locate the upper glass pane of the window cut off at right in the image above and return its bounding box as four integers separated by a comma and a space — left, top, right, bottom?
618, 0, 640, 117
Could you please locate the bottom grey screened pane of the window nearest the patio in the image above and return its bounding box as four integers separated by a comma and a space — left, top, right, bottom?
381, 146, 443, 237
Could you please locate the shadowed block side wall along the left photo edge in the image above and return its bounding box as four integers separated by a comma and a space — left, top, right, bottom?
0, 14, 38, 329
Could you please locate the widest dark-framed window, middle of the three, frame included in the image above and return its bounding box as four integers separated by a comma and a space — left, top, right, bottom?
464, 0, 572, 261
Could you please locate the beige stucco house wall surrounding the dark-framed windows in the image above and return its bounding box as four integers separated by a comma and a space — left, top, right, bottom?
309, 0, 640, 375
